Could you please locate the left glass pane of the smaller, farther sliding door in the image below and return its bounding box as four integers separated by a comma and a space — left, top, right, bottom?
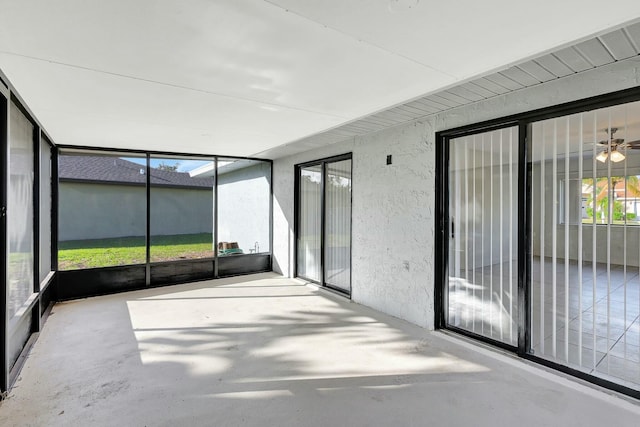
297, 165, 322, 282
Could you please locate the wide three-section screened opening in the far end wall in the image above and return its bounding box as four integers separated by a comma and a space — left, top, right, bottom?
58, 149, 271, 278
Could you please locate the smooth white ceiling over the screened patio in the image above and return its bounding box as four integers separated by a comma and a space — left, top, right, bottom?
0, 0, 640, 156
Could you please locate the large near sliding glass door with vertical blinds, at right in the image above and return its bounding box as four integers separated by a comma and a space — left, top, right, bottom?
436, 97, 640, 396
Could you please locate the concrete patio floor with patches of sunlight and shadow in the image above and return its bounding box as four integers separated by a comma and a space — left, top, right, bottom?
0, 274, 640, 426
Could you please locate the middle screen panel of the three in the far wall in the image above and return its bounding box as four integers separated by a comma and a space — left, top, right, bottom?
150, 157, 215, 262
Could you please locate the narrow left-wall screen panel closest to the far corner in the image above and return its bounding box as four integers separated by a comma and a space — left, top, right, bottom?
39, 141, 51, 283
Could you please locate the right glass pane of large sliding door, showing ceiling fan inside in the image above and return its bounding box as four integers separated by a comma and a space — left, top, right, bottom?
531, 102, 640, 389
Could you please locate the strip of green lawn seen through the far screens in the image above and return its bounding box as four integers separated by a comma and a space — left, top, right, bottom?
58, 233, 214, 270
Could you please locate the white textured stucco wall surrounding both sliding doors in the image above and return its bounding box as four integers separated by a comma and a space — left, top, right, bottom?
273, 58, 640, 329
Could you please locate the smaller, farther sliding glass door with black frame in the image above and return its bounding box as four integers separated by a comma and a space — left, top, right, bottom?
296, 156, 351, 294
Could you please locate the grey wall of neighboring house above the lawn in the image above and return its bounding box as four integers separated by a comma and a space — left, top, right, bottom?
58, 181, 213, 241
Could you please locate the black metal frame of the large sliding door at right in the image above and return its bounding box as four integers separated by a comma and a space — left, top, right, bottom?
434, 87, 640, 399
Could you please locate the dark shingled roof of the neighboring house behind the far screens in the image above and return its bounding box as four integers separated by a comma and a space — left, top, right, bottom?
58, 155, 213, 188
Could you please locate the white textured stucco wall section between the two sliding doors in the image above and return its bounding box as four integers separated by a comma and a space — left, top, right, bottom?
352, 122, 435, 326
